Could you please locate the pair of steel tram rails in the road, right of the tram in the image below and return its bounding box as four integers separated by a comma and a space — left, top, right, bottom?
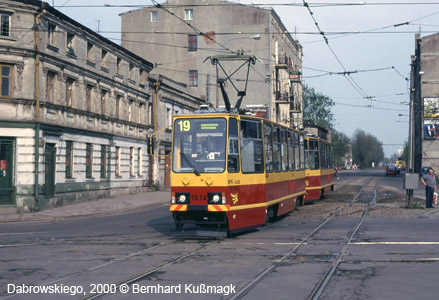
228, 177, 380, 300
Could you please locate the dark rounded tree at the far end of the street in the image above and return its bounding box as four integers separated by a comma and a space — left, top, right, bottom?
352, 129, 384, 167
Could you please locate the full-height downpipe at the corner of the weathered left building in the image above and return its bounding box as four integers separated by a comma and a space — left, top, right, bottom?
34, 11, 44, 207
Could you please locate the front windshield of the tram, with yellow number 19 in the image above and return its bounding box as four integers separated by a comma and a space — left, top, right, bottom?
172, 118, 227, 174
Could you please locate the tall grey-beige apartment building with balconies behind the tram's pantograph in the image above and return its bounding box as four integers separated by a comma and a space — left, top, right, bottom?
121, 0, 303, 127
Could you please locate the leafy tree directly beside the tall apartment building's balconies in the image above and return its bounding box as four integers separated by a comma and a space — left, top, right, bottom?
303, 85, 335, 128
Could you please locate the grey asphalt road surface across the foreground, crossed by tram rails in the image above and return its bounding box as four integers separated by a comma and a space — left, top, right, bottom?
0, 171, 439, 299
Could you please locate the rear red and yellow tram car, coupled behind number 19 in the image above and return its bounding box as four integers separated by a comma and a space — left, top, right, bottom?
304, 135, 335, 203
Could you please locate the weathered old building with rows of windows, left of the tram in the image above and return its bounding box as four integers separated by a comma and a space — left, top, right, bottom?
0, 1, 158, 212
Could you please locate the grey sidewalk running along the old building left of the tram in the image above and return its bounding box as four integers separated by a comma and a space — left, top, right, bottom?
0, 191, 171, 223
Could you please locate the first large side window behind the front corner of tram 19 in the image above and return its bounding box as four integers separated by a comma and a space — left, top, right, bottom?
241, 120, 264, 173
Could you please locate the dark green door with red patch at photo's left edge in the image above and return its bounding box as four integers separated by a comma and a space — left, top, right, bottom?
0, 139, 14, 205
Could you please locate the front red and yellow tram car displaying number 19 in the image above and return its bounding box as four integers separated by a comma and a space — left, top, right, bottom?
170, 112, 305, 234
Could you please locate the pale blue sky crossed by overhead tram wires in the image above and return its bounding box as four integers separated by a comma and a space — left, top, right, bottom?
48, 0, 439, 157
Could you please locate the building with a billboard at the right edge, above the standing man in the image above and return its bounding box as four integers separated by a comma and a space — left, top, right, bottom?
410, 33, 439, 172
